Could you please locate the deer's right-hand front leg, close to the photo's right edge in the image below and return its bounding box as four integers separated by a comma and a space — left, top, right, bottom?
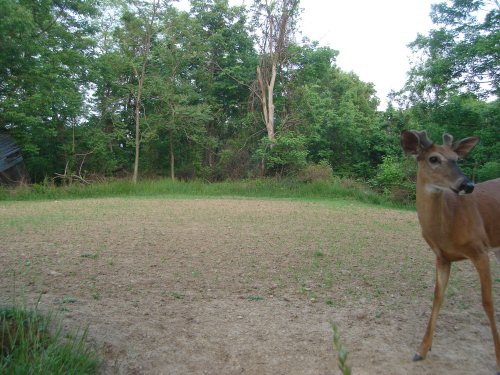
472, 253, 500, 375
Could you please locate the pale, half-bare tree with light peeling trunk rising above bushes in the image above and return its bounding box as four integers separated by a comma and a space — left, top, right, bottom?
253, 0, 300, 142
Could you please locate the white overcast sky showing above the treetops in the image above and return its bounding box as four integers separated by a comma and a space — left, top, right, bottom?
180, 0, 436, 109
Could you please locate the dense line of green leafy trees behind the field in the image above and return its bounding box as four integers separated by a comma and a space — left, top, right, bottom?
0, 0, 500, 200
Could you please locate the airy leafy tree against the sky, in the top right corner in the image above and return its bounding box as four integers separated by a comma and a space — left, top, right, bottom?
400, 0, 500, 104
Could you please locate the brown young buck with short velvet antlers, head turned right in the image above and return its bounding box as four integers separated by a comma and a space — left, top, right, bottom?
401, 131, 500, 375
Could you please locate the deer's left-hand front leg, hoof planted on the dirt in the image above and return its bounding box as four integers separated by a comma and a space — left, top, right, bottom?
413, 257, 451, 361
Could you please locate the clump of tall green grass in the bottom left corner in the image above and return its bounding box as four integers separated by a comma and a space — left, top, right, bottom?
0, 307, 99, 375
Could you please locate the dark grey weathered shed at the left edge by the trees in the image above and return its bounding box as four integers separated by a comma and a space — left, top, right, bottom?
0, 133, 29, 186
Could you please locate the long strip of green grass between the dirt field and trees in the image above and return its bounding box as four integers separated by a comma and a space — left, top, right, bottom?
0, 178, 408, 207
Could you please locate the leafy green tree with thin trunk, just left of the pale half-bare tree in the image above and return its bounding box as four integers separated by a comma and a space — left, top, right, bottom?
145, 8, 211, 179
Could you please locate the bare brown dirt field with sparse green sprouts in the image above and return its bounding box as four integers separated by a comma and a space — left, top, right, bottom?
0, 198, 500, 375
